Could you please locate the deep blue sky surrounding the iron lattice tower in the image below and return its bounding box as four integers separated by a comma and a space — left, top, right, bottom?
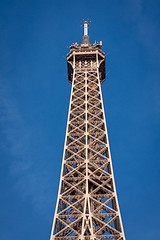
0, 0, 160, 240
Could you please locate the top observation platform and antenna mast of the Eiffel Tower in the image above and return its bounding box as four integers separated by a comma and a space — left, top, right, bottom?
67, 21, 105, 83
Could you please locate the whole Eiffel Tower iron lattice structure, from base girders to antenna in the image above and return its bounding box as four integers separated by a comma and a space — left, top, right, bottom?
50, 21, 125, 240
